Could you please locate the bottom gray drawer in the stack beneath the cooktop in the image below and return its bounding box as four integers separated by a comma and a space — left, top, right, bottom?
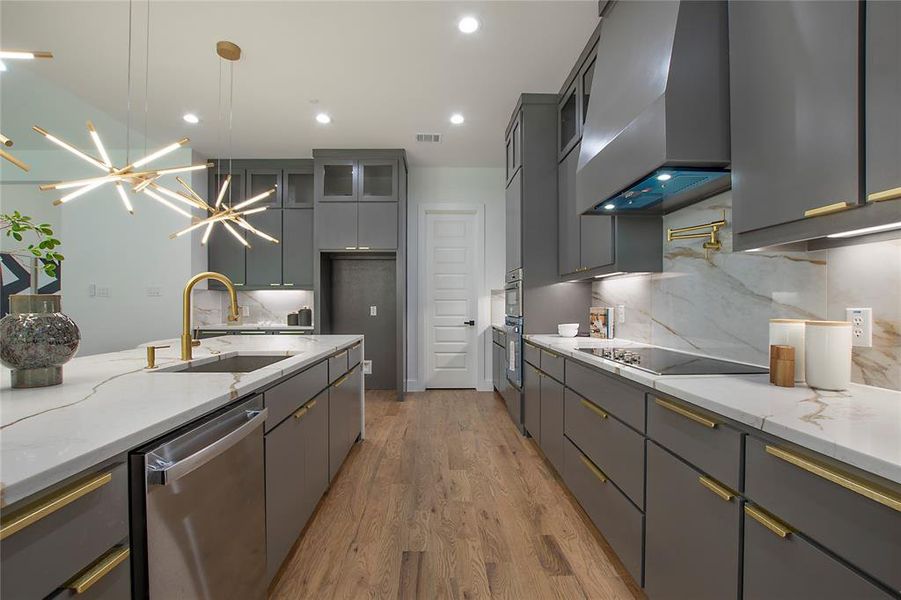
563, 439, 644, 585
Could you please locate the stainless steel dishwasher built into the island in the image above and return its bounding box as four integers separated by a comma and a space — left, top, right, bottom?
129, 396, 266, 600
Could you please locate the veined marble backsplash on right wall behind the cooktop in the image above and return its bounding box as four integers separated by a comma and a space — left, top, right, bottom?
592, 192, 901, 389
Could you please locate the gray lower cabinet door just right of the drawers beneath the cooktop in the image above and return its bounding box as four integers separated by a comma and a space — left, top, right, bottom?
644, 441, 741, 600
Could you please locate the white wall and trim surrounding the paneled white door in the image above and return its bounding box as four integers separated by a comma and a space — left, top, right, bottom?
407, 167, 505, 391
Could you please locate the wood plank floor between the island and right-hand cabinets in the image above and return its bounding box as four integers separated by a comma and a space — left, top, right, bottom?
270, 390, 643, 600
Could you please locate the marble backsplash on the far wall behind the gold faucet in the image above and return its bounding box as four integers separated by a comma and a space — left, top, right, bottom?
192, 290, 313, 327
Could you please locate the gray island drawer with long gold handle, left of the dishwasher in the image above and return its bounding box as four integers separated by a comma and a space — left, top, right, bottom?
0, 464, 128, 598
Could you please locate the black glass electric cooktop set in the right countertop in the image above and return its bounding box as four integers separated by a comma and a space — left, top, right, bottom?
578, 347, 769, 375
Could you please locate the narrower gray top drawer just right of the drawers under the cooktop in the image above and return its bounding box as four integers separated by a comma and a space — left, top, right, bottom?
648, 394, 742, 490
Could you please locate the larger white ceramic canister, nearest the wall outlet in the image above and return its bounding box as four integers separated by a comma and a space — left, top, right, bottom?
804, 321, 851, 390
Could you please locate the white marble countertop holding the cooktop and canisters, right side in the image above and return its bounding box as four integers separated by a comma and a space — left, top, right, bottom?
525, 335, 901, 483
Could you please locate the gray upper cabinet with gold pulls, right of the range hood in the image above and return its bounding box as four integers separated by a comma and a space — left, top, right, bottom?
729, 0, 901, 250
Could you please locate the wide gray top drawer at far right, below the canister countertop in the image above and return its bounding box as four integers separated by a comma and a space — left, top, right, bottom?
745, 436, 901, 590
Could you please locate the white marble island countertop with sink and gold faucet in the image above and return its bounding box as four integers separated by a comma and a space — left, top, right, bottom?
0, 335, 362, 506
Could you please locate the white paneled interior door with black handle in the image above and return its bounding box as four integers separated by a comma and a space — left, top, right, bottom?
420, 210, 480, 388
